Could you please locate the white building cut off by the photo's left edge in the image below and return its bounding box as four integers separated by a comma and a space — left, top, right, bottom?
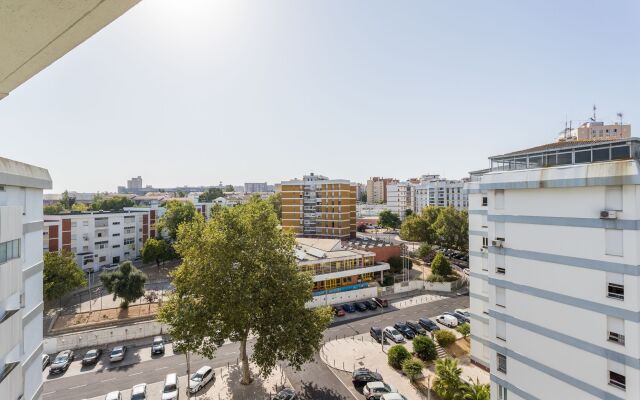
0, 158, 51, 399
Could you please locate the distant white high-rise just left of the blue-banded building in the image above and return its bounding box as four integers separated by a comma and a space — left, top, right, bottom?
411, 175, 469, 213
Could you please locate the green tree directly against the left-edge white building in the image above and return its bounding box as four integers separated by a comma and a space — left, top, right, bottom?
43, 250, 87, 300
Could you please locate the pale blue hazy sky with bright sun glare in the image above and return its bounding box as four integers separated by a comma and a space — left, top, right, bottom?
0, 0, 640, 191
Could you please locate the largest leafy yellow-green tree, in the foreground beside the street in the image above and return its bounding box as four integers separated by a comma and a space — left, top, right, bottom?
160, 198, 332, 384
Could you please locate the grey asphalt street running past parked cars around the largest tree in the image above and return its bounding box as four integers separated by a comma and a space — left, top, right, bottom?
43, 296, 469, 400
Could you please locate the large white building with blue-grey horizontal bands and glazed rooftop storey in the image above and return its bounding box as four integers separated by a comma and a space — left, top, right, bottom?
467, 138, 640, 400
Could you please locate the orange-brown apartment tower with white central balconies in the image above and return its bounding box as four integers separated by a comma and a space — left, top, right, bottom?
280, 173, 356, 238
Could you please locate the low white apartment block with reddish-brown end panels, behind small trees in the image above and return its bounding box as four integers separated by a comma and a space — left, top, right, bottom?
42, 207, 154, 271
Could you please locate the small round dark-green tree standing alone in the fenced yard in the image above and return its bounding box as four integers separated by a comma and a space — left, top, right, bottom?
100, 261, 147, 308
